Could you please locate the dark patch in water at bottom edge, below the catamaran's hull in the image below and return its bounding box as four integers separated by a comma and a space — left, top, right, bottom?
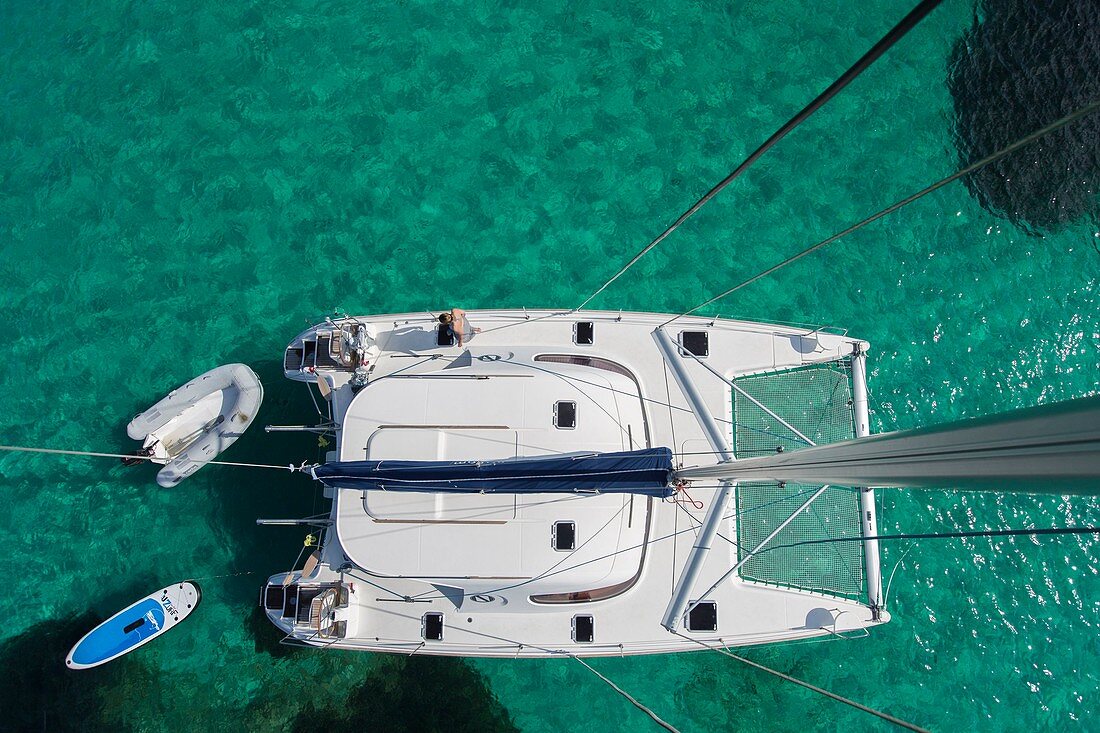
292, 656, 519, 733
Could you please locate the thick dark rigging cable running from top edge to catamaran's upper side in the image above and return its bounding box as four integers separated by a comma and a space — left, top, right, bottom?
573, 0, 941, 311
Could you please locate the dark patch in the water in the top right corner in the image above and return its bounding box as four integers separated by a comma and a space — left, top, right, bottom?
947, 0, 1100, 234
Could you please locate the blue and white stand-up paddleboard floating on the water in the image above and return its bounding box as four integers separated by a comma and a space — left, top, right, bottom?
65, 580, 202, 669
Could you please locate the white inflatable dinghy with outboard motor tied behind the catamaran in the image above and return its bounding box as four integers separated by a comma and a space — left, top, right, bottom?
127, 364, 264, 488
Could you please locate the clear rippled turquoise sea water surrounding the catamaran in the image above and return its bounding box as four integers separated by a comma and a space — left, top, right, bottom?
0, 0, 1100, 731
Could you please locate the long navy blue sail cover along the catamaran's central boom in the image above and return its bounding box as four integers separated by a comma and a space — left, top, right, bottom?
310, 448, 674, 496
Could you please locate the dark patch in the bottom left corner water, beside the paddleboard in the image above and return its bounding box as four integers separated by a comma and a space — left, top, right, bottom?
0, 612, 156, 731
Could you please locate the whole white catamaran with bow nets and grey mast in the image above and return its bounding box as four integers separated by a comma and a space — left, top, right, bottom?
261, 310, 1100, 657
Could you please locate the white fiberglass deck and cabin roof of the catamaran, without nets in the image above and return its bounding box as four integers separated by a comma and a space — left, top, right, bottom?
268, 311, 889, 656
